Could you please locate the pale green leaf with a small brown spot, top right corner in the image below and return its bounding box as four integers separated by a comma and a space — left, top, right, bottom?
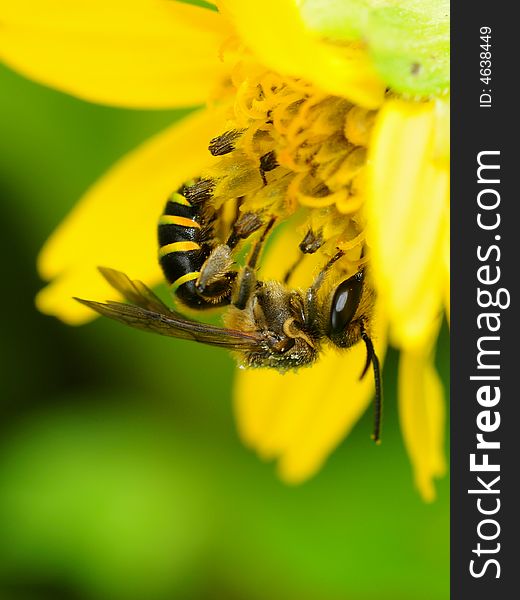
299, 0, 450, 97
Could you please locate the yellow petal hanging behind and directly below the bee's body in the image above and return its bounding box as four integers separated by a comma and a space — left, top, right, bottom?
234, 228, 385, 483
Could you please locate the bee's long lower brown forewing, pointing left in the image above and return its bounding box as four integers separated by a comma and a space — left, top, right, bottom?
75, 298, 262, 351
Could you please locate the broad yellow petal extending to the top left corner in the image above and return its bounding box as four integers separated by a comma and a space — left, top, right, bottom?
0, 0, 229, 108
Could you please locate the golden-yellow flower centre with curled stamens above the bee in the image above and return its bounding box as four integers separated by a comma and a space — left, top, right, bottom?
205, 59, 376, 267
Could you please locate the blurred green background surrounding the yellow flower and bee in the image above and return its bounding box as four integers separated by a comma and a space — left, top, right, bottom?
0, 57, 449, 600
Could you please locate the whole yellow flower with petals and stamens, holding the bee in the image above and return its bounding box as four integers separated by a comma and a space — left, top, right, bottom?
0, 0, 449, 499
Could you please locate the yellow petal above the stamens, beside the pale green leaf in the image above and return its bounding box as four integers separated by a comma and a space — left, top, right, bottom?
217, 0, 384, 108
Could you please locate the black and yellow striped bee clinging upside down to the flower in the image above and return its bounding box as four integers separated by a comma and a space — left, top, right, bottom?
76, 179, 382, 442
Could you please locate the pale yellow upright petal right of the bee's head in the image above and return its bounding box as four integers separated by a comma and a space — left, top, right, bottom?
366, 100, 449, 347
